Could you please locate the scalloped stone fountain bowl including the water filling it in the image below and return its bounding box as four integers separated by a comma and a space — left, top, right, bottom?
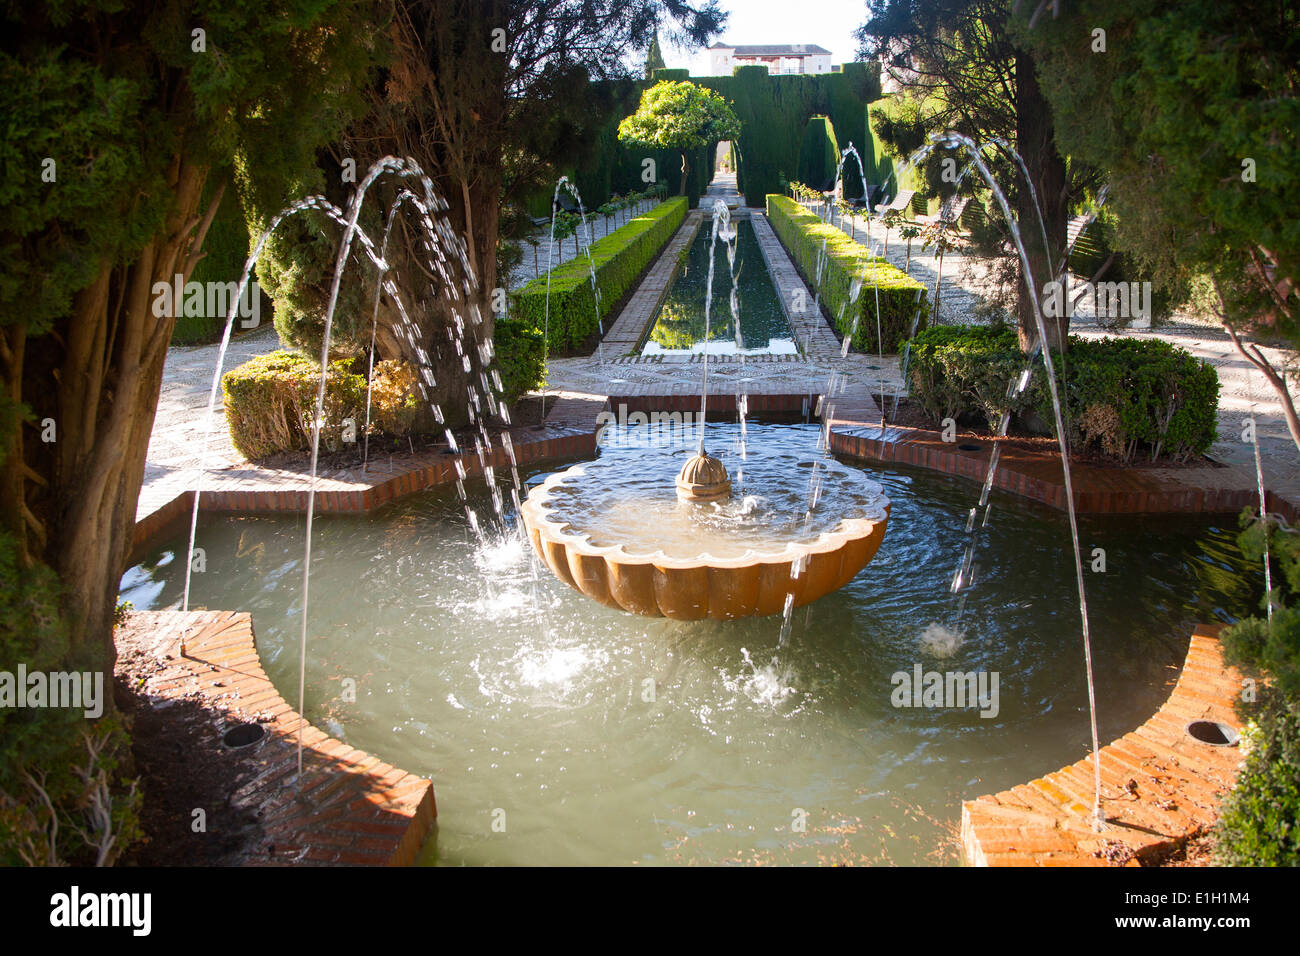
521, 425, 889, 620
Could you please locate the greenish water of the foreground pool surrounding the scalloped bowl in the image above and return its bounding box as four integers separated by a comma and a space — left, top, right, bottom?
122, 425, 1262, 865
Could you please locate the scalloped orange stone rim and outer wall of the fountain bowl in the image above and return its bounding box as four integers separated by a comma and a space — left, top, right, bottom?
520, 466, 889, 620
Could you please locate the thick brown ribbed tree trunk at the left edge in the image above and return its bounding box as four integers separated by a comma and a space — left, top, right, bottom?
4, 156, 213, 686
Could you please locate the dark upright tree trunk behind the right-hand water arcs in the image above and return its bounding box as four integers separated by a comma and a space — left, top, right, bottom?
1014, 51, 1070, 352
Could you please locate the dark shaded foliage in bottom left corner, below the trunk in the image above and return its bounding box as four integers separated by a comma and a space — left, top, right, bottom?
0, 535, 140, 866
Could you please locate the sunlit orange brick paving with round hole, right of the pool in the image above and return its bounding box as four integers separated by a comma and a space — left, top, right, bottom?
962, 627, 1243, 866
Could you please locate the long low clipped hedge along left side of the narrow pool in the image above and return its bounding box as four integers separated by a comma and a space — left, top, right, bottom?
510, 196, 688, 351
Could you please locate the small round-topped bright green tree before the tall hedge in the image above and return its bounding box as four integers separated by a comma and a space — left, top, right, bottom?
619, 81, 740, 196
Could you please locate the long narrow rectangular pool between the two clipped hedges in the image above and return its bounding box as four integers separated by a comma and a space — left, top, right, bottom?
641, 219, 798, 355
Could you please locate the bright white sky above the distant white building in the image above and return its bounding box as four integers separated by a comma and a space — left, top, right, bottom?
663, 0, 867, 77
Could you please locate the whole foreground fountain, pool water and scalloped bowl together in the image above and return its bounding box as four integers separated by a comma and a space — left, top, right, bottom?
122, 134, 1253, 865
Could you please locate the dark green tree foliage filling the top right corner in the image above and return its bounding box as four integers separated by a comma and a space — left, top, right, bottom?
1018, 0, 1300, 341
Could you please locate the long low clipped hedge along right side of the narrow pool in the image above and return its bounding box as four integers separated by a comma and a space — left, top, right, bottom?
767, 194, 930, 352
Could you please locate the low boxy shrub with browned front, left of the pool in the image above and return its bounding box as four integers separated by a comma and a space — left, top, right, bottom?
221, 350, 365, 462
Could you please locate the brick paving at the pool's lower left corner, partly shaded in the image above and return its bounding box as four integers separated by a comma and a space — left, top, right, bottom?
118, 611, 437, 866
